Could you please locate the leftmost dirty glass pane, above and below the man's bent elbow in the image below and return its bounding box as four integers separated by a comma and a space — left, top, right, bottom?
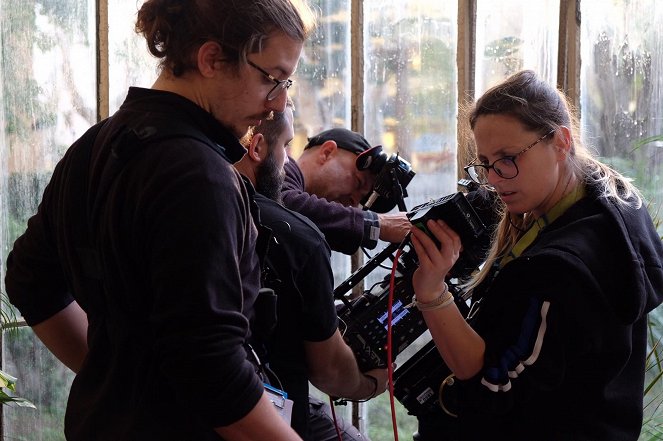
0, 0, 97, 441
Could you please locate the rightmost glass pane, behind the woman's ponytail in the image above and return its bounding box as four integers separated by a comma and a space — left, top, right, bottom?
580, 0, 663, 234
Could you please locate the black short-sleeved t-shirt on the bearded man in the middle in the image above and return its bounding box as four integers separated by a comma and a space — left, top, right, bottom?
255, 194, 338, 438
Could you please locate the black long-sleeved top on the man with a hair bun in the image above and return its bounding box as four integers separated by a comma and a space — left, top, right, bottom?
6, 88, 263, 441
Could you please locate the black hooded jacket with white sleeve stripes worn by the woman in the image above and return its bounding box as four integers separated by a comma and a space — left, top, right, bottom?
461, 181, 663, 441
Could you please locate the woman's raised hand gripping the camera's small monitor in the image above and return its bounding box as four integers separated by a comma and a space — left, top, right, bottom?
410, 220, 461, 303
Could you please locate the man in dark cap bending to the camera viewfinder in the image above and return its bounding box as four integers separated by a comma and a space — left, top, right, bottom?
283, 128, 410, 254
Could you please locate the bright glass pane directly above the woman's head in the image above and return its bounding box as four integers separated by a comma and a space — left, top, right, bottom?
475, 0, 559, 97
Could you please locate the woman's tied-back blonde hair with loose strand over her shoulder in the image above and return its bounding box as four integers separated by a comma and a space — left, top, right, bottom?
468, 70, 642, 288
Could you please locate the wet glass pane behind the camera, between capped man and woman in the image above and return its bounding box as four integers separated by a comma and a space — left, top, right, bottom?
364, 0, 458, 439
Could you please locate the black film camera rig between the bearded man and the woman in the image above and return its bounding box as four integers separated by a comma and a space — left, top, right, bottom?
334, 192, 488, 415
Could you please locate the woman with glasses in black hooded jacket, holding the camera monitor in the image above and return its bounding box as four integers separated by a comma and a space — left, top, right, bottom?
412, 71, 663, 441
